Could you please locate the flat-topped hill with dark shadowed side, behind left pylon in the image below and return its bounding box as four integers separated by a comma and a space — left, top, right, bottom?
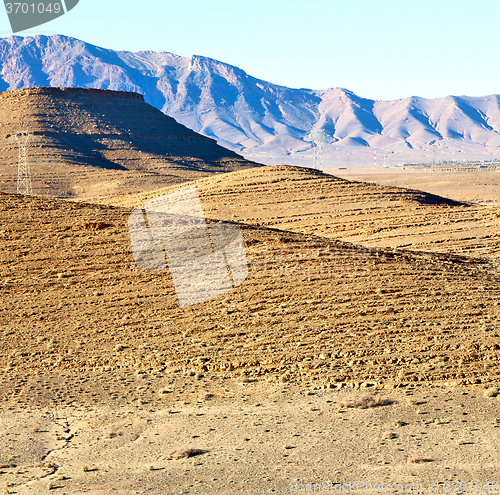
0, 88, 258, 201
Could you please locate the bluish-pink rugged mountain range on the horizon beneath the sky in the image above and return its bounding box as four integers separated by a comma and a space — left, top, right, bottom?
0, 35, 500, 166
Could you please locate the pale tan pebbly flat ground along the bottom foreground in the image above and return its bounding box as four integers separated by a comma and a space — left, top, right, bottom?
0, 388, 500, 495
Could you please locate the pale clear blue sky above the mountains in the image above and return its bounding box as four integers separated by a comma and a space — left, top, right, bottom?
0, 0, 500, 100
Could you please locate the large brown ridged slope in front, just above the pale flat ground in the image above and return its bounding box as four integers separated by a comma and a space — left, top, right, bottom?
0, 190, 500, 403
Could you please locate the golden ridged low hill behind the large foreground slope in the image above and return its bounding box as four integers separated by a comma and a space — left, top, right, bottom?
113, 165, 500, 261
